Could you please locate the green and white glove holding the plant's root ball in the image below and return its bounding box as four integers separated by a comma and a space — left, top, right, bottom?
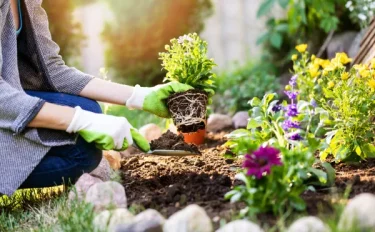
126, 82, 193, 118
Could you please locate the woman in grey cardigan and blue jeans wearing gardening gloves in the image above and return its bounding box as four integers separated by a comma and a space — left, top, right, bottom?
0, 0, 191, 195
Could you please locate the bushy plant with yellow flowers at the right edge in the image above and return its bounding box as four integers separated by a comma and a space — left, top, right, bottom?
294, 44, 375, 161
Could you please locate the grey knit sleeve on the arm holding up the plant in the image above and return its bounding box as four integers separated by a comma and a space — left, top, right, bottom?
30, 0, 94, 95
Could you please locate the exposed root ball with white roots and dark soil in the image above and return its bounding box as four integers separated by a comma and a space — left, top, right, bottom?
167, 89, 208, 133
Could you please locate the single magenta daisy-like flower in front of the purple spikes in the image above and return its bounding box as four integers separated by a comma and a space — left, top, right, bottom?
242, 147, 282, 179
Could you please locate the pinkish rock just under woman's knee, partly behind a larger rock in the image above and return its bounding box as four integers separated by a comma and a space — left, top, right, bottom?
68, 173, 103, 201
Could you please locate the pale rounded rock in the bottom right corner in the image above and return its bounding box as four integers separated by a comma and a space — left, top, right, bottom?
338, 193, 375, 231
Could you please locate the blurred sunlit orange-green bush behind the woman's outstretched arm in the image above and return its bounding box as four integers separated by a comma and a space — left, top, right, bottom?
103, 0, 212, 85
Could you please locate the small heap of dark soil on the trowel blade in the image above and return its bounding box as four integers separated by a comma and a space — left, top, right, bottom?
150, 130, 201, 154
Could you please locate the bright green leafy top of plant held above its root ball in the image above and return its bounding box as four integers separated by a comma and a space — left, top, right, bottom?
159, 33, 216, 94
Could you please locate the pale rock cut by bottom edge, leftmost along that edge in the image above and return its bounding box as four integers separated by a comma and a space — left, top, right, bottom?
93, 209, 134, 232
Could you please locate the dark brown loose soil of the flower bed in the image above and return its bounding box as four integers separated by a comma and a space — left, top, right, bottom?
122, 132, 375, 228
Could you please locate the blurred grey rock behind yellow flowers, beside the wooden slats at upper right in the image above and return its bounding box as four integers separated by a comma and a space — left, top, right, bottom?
327, 31, 358, 59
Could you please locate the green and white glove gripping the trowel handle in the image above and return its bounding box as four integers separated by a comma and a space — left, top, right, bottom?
66, 106, 150, 152
